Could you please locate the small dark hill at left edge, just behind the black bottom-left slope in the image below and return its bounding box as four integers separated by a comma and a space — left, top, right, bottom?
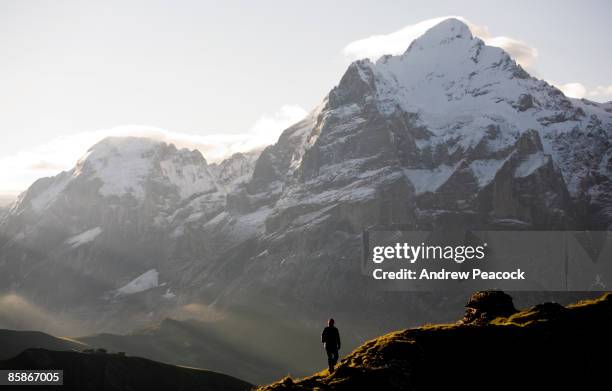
0, 329, 88, 360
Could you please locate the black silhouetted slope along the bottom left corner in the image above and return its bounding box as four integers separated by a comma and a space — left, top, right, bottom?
0, 349, 253, 391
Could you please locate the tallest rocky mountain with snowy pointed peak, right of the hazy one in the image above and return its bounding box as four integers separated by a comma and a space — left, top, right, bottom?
193, 19, 612, 318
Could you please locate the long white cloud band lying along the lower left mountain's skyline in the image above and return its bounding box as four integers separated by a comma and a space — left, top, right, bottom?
0, 105, 307, 198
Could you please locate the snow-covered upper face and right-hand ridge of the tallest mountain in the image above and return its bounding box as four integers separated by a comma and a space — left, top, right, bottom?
330, 19, 612, 196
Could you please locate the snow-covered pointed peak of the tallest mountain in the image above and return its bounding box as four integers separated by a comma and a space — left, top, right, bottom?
371, 24, 539, 117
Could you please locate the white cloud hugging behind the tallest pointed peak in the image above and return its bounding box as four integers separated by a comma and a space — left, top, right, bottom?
342, 16, 538, 69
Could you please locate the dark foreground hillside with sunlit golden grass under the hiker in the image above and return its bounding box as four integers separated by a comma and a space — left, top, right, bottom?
261, 291, 612, 390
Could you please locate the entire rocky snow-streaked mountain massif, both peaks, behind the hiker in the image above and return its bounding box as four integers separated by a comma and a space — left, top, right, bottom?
0, 19, 612, 336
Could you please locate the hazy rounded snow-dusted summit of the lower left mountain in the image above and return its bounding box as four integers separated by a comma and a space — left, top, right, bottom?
16, 137, 215, 211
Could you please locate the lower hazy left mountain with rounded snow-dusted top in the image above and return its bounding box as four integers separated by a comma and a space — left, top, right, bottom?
0, 137, 257, 329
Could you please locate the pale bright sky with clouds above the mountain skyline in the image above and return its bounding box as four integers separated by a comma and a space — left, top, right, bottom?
0, 0, 612, 204
